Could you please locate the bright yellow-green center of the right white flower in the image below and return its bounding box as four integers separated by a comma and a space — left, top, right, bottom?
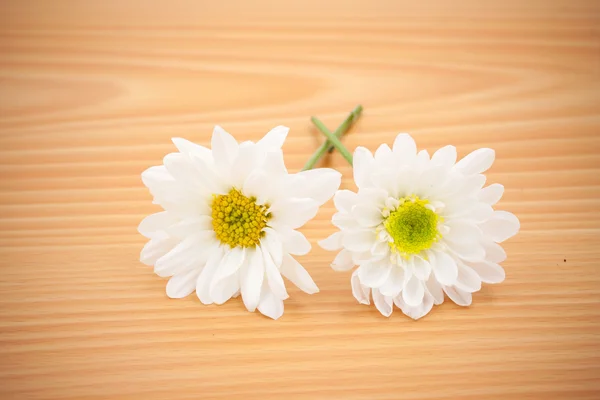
383, 196, 441, 257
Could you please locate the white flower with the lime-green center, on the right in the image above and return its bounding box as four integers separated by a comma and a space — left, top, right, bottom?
320, 134, 519, 319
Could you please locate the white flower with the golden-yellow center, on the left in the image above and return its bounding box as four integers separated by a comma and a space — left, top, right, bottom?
138, 126, 341, 319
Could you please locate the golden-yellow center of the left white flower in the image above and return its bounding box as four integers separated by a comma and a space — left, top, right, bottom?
211, 188, 271, 248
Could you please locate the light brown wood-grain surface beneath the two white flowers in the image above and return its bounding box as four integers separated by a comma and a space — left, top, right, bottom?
0, 0, 600, 400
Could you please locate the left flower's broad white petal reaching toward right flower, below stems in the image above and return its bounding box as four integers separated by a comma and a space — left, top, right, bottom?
292, 168, 342, 205
